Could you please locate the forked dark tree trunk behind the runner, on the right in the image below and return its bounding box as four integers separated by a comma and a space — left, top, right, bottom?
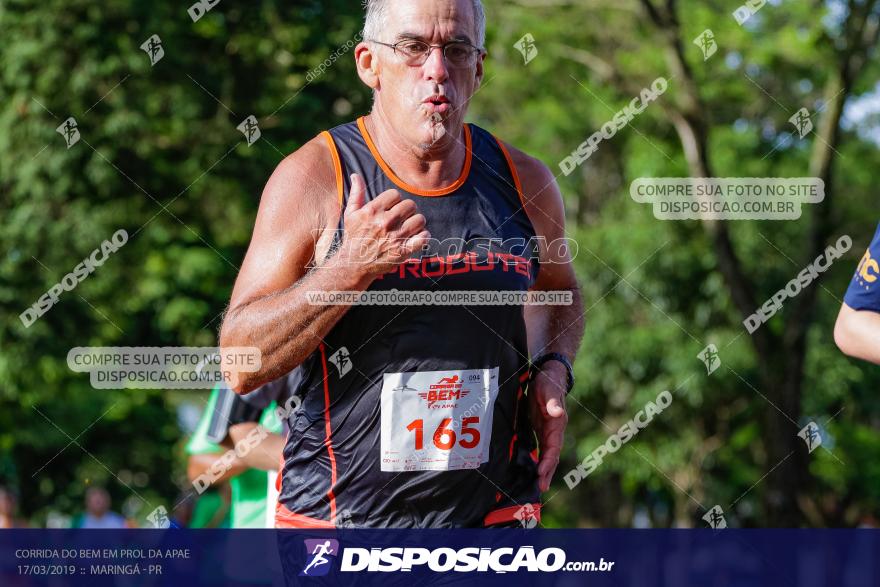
641, 0, 880, 527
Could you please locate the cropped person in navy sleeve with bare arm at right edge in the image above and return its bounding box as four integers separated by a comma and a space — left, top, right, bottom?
834, 225, 880, 364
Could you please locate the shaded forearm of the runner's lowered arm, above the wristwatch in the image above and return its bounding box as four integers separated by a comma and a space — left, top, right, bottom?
526, 287, 584, 360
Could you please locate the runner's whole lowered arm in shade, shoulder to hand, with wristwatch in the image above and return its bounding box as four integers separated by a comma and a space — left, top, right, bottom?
508, 147, 584, 491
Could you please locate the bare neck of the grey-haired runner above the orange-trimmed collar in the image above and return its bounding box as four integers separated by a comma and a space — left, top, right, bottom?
364, 107, 467, 190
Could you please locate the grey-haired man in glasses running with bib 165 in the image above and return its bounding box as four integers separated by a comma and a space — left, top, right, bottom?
221, 0, 583, 528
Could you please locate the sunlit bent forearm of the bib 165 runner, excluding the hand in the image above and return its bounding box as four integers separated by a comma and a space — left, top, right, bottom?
220, 251, 373, 393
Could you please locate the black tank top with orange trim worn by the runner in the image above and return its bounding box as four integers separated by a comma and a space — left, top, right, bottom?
279, 118, 539, 528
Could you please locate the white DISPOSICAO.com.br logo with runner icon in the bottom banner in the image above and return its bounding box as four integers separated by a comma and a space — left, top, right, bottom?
300, 539, 614, 577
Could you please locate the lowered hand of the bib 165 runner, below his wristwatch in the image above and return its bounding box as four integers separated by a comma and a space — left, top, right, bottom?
529, 361, 568, 492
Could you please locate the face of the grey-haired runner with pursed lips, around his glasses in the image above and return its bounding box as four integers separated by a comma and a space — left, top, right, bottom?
369, 0, 484, 150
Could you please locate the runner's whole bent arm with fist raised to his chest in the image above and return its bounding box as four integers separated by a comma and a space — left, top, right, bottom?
220, 136, 429, 393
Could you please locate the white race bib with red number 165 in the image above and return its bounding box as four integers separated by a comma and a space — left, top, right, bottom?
381, 367, 498, 471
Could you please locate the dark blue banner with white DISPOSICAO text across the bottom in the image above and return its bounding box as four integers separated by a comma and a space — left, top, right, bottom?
0, 529, 880, 587
